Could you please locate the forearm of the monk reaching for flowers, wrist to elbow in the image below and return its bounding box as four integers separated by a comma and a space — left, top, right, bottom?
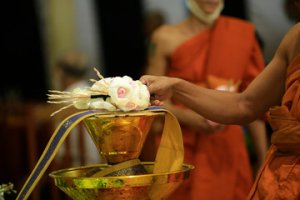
172, 79, 254, 124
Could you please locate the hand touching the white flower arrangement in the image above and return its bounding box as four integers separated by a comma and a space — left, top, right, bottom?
140, 75, 178, 106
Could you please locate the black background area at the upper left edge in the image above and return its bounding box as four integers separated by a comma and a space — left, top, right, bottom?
0, 0, 47, 102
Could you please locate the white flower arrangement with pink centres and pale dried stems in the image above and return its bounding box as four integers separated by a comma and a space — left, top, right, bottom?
48, 69, 150, 116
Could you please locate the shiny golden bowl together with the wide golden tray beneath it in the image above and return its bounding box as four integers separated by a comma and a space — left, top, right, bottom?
50, 111, 193, 200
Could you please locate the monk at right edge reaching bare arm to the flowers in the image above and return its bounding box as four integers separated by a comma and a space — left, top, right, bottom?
140, 19, 300, 200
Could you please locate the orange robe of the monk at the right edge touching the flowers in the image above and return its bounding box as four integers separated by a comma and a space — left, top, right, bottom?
249, 55, 300, 200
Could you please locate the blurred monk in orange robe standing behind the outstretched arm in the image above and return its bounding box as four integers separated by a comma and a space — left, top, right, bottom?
146, 0, 265, 200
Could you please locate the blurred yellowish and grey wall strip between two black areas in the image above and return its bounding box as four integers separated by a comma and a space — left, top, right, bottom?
36, 0, 105, 83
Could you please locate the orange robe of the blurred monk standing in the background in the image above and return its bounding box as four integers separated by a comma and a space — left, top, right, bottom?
167, 17, 264, 200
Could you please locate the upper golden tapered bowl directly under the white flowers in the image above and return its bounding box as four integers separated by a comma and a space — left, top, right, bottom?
84, 111, 164, 164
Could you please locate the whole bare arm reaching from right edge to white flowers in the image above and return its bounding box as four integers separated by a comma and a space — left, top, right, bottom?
140, 23, 300, 124
